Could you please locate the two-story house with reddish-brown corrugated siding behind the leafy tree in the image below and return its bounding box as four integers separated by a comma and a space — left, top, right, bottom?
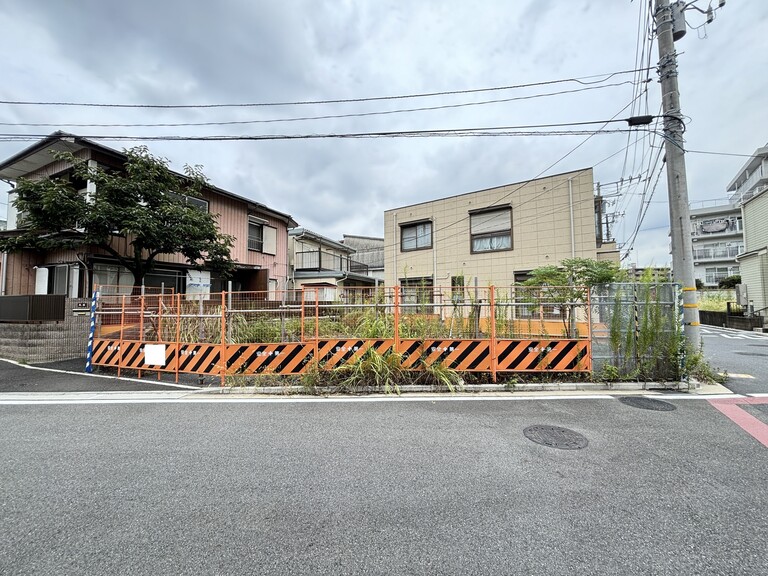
0, 132, 296, 297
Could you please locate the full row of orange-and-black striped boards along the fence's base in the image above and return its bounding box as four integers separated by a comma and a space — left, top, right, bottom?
92, 339, 591, 375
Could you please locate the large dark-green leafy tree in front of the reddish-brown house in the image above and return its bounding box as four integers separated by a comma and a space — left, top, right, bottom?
0, 146, 234, 286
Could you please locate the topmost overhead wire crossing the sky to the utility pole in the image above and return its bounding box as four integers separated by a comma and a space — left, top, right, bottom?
0, 70, 656, 109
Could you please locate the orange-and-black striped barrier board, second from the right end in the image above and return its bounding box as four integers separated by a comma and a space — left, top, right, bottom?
400, 339, 491, 372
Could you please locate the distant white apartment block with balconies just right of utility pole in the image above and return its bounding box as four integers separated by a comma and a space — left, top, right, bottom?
691, 203, 744, 288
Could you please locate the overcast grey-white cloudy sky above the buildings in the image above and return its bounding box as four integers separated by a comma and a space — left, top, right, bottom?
0, 0, 768, 265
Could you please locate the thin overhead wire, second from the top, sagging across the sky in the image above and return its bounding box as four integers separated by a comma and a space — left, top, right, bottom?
0, 81, 632, 128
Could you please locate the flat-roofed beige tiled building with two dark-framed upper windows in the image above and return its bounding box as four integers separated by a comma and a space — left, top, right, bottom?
384, 168, 619, 287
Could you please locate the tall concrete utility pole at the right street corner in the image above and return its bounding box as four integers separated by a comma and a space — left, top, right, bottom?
654, 0, 701, 350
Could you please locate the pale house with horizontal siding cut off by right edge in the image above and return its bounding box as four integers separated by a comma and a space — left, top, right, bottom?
736, 190, 768, 317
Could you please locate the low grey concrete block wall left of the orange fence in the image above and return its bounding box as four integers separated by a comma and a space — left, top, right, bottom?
0, 298, 90, 364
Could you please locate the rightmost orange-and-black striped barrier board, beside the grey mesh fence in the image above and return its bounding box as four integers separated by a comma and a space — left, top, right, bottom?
496, 340, 591, 372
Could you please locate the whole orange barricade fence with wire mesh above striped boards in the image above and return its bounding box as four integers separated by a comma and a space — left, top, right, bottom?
92, 286, 592, 383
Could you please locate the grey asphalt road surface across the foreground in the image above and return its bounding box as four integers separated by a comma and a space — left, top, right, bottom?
0, 396, 768, 576
